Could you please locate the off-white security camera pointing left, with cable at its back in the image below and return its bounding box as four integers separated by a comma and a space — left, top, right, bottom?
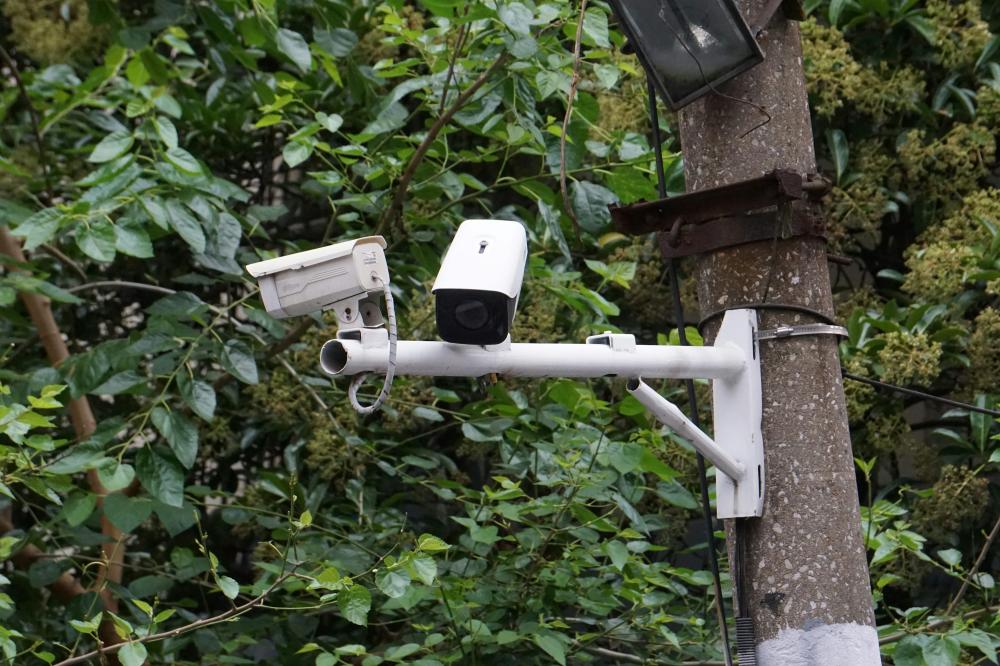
247, 236, 389, 326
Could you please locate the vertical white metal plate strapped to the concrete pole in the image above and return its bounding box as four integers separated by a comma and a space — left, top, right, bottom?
712, 310, 765, 518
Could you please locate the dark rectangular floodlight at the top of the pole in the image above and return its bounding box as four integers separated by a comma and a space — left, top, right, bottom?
611, 0, 764, 110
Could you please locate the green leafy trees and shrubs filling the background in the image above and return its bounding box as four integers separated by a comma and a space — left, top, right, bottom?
0, 0, 1000, 666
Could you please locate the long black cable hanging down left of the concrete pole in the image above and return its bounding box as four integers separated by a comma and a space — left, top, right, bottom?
646, 72, 733, 666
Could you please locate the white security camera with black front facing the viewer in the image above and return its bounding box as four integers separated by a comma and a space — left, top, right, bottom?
433, 220, 528, 346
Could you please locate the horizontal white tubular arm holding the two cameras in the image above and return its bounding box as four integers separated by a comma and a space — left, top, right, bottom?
320, 329, 747, 379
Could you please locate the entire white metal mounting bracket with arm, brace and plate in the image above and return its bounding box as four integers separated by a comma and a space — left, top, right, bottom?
320, 310, 764, 518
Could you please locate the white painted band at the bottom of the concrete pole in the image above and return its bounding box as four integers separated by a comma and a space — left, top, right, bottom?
757, 624, 882, 666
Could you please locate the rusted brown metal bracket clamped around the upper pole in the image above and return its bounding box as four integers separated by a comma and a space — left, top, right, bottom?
609, 171, 829, 258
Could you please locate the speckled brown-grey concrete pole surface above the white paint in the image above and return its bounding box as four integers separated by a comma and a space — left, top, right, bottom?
681, 0, 877, 654
